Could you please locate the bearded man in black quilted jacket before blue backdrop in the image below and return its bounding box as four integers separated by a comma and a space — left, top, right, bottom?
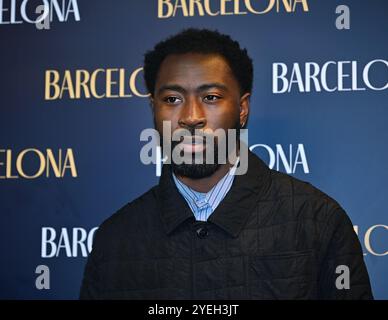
80, 29, 372, 299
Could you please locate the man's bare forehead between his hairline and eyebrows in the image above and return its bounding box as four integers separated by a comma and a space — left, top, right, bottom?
156, 53, 238, 89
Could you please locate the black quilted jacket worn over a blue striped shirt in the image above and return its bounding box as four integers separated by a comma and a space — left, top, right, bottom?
80, 153, 372, 299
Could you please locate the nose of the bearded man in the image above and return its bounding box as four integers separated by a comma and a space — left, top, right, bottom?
178, 97, 206, 129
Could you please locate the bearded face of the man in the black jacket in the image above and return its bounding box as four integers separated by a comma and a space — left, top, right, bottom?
151, 53, 249, 178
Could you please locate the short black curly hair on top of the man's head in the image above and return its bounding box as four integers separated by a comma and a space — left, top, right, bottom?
144, 28, 253, 96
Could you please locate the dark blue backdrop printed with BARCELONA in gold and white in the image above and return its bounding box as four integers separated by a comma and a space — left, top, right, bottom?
0, 0, 388, 299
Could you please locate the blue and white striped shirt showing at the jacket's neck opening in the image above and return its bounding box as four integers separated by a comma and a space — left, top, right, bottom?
172, 168, 235, 221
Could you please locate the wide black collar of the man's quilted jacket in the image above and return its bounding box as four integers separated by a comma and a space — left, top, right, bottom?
158, 151, 270, 237
